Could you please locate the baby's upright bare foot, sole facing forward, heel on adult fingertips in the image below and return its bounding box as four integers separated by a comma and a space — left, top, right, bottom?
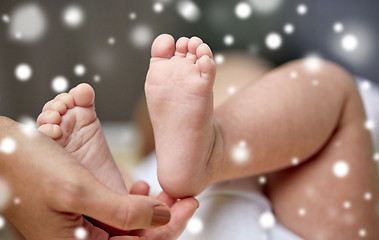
145, 34, 216, 198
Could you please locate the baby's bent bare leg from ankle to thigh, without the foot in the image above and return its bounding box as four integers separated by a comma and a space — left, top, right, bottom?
214, 60, 379, 239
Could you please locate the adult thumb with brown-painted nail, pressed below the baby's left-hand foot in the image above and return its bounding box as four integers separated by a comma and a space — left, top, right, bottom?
59, 172, 171, 230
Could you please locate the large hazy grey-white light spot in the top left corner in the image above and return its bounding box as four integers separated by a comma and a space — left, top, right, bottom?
8, 3, 47, 43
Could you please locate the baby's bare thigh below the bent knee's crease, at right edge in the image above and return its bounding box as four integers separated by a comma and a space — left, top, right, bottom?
267, 73, 379, 239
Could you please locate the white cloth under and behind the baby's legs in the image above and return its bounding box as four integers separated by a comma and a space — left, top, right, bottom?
133, 79, 379, 240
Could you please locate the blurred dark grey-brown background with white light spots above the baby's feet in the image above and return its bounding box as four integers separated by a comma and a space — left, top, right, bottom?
0, 0, 379, 239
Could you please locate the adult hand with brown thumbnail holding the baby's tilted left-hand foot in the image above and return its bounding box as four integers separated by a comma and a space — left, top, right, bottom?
0, 117, 170, 240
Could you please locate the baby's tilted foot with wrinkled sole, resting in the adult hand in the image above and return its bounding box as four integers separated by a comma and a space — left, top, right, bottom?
37, 84, 127, 194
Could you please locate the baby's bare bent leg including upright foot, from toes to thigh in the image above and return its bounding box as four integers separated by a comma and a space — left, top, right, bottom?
145, 34, 379, 239
